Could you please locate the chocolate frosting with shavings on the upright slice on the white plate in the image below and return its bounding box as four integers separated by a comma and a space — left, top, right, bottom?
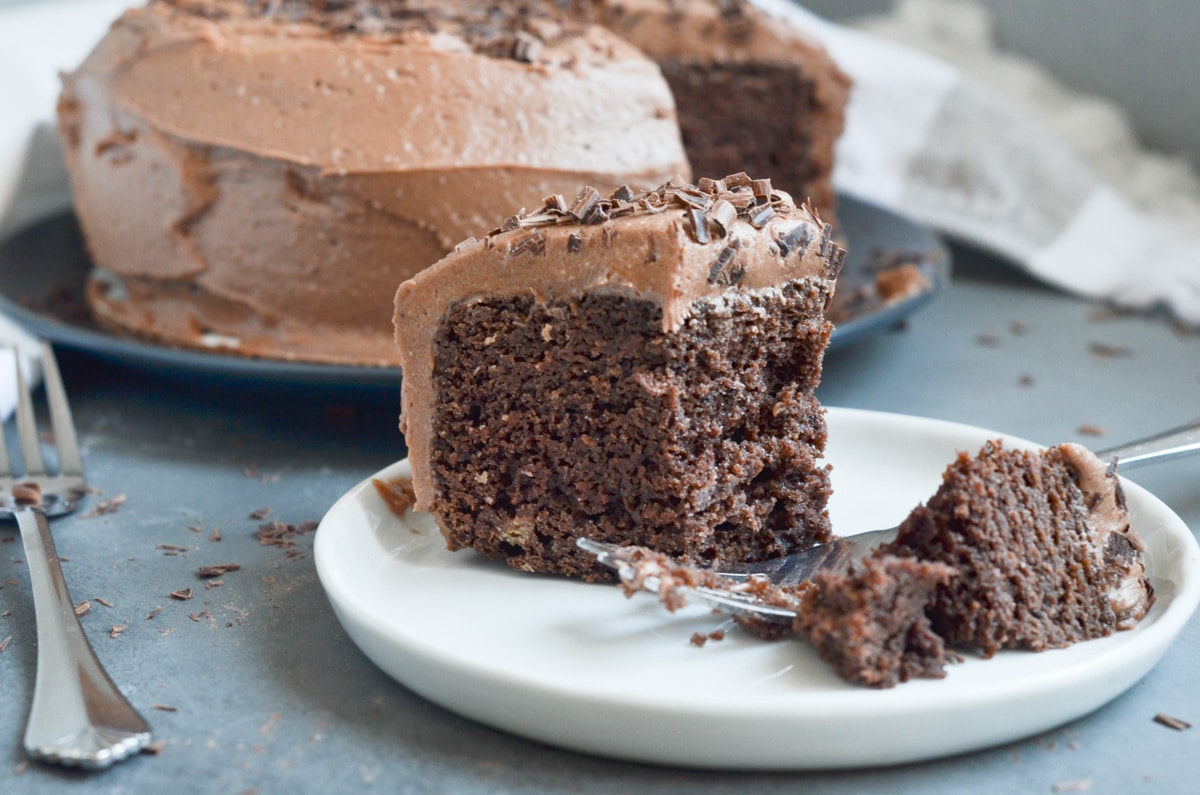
395, 174, 845, 510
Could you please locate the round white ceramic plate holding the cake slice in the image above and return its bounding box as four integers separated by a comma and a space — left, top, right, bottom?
316, 408, 1200, 769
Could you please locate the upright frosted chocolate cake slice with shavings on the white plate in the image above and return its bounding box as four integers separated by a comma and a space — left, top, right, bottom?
395, 174, 844, 579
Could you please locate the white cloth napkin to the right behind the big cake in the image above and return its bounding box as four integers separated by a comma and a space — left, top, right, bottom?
755, 0, 1200, 323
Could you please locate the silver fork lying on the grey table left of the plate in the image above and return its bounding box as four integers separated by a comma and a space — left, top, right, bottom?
0, 345, 150, 770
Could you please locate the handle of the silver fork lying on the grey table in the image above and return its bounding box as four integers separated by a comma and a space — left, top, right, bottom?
16, 508, 150, 769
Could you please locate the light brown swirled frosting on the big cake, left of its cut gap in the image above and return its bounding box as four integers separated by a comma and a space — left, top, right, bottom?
60, 0, 688, 364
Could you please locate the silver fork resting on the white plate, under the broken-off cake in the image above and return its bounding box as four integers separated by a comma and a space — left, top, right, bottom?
576, 420, 1200, 624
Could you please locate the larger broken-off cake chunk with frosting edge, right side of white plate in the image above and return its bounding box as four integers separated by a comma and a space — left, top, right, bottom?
888, 441, 1153, 657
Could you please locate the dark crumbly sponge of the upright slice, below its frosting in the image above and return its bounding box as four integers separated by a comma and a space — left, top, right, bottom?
431, 282, 829, 579
